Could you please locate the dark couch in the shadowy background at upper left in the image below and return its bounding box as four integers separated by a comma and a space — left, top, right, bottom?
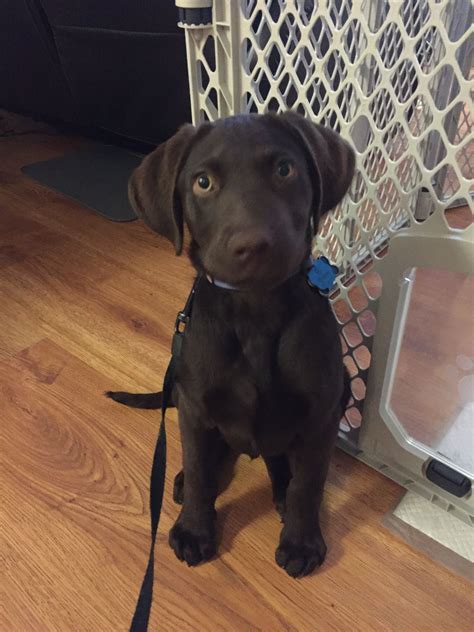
0, 0, 190, 143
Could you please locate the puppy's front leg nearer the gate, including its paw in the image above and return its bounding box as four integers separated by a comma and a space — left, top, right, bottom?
275, 424, 337, 577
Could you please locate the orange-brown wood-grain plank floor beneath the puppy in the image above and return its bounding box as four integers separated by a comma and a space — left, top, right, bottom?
0, 126, 474, 632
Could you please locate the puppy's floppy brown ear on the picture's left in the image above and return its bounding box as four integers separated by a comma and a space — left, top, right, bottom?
128, 125, 197, 255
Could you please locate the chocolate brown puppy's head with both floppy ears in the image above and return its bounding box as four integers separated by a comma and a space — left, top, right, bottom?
129, 112, 354, 288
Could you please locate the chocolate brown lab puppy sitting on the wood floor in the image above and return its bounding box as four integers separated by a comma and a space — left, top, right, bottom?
112, 112, 354, 577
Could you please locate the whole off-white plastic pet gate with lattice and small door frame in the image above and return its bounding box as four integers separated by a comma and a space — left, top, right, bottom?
176, 0, 474, 524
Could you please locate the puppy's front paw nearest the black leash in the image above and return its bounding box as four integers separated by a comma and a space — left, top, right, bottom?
169, 518, 217, 566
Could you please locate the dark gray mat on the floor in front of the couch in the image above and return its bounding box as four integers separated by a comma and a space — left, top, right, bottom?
22, 145, 143, 222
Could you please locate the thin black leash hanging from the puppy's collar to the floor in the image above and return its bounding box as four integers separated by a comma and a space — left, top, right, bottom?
130, 275, 201, 632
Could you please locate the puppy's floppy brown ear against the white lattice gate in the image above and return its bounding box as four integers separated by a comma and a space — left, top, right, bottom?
281, 112, 355, 222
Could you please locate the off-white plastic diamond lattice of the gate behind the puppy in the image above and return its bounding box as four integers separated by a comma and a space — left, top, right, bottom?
180, 0, 474, 442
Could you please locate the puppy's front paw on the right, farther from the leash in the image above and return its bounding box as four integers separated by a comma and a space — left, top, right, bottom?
275, 535, 327, 577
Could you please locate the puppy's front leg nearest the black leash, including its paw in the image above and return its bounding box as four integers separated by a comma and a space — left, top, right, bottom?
169, 408, 222, 566
